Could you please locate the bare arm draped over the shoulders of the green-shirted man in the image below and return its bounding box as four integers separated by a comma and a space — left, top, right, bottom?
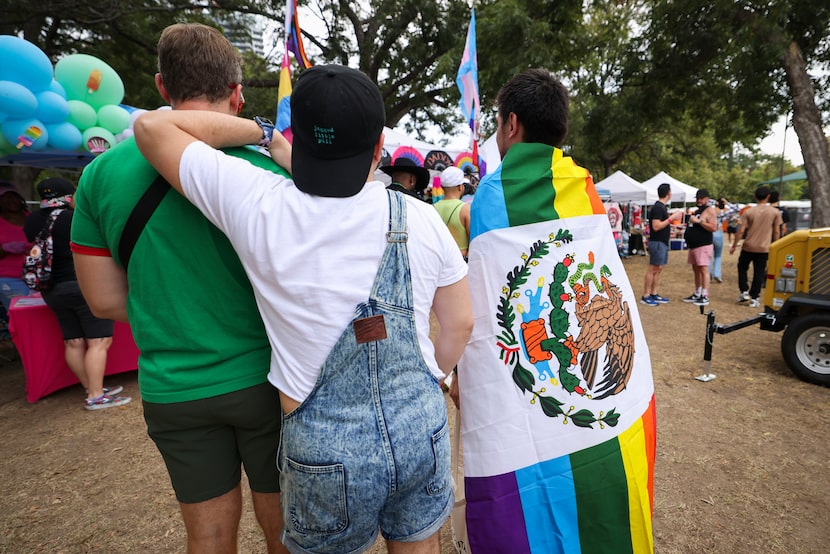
134, 110, 291, 193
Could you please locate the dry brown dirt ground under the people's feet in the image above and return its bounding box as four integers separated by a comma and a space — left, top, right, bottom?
0, 251, 830, 554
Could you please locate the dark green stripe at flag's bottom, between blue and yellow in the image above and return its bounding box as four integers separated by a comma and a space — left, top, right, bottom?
570, 439, 633, 554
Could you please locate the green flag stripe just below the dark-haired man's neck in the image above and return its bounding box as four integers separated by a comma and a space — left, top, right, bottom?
501, 143, 559, 227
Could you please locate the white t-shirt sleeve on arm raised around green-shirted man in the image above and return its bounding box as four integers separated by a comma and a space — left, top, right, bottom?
179, 141, 286, 237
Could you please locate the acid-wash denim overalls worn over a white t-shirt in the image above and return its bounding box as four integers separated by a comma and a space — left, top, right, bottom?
278, 191, 453, 554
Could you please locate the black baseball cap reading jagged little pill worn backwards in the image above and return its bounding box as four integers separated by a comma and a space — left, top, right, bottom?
291, 65, 386, 198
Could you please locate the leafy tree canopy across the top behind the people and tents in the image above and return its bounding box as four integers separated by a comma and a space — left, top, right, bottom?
0, 0, 830, 225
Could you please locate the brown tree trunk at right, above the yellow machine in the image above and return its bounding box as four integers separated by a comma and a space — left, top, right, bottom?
782, 42, 830, 227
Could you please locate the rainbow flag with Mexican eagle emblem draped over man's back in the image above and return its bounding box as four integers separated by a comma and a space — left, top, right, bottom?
458, 143, 656, 554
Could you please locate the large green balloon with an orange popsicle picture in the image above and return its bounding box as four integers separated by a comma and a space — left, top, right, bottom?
55, 54, 124, 110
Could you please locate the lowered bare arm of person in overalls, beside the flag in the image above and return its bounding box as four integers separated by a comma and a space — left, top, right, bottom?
432, 277, 473, 373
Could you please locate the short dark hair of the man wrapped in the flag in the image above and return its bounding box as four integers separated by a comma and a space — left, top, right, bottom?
496, 69, 569, 147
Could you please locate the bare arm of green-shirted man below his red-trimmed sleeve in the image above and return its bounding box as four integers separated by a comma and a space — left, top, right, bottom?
72, 253, 128, 322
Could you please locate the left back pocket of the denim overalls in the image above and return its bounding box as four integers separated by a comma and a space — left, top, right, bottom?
282, 457, 348, 534
